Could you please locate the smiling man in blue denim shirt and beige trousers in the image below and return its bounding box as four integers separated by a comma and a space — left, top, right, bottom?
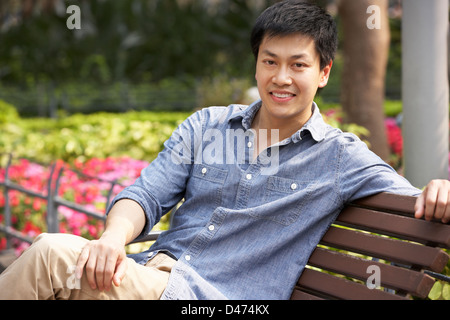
0, 1, 450, 299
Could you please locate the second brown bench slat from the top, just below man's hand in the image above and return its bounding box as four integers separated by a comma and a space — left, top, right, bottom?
337, 207, 450, 248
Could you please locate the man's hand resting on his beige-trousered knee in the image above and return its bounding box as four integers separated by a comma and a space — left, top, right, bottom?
75, 234, 127, 291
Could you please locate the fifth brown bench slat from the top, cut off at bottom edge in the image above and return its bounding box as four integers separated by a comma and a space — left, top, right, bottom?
297, 269, 406, 300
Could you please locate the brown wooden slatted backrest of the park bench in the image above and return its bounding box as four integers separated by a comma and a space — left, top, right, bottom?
291, 193, 450, 300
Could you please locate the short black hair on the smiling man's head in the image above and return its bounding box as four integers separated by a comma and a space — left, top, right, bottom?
251, 0, 338, 70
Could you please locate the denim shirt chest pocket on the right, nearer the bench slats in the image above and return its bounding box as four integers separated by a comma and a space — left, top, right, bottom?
251, 176, 315, 226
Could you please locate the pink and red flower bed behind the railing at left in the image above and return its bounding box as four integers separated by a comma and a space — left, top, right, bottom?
0, 157, 155, 254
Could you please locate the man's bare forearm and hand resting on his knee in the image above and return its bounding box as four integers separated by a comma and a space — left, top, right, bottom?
75, 199, 145, 291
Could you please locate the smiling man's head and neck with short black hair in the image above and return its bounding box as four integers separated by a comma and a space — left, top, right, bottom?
252, 0, 337, 131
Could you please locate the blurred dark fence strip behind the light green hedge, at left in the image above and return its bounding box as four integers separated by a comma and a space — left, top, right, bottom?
0, 83, 198, 118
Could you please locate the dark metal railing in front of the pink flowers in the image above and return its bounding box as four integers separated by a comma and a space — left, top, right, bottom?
0, 154, 119, 249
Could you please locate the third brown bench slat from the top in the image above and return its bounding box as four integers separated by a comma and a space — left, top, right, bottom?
320, 226, 449, 272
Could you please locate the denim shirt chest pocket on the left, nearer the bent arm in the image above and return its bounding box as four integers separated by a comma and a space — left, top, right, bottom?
185, 164, 228, 217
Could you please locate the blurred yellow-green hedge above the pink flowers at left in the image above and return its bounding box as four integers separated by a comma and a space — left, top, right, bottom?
0, 112, 189, 162
